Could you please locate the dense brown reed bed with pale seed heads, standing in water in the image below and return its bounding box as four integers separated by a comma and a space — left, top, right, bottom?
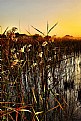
0, 36, 81, 121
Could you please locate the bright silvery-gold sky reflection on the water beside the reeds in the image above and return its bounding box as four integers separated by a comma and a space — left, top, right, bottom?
51, 53, 81, 101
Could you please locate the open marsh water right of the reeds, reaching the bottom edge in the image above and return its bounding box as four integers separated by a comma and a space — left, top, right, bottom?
45, 53, 81, 121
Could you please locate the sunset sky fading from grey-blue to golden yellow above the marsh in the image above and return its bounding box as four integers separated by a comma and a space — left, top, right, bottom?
0, 0, 81, 37
